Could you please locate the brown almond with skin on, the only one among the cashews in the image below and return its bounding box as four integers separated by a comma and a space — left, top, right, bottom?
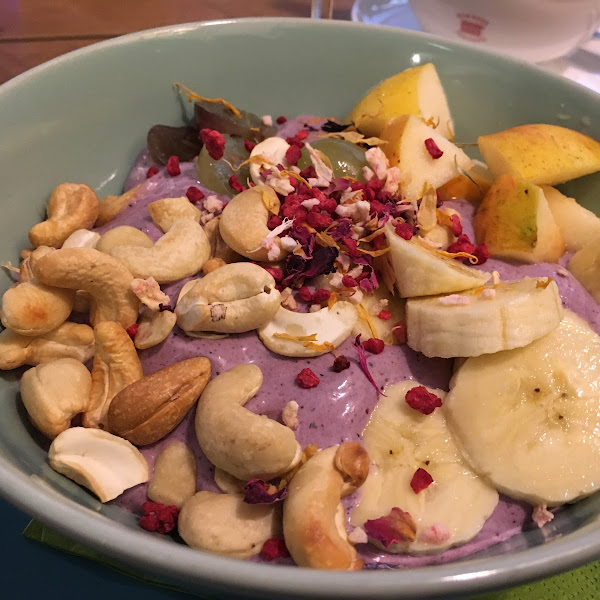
108, 357, 211, 446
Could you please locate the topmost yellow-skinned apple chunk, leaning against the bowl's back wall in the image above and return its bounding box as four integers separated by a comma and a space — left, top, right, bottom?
346, 63, 454, 140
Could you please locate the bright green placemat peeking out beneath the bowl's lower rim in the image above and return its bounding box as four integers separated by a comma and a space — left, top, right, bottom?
23, 521, 600, 600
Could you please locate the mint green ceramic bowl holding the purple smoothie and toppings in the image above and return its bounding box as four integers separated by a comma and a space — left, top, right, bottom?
0, 19, 600, 600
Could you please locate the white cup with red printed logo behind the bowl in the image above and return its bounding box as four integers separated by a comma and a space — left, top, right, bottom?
409, 0, 600, 62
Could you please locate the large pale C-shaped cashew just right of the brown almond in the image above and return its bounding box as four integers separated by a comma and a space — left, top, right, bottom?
196, 364, 302, 481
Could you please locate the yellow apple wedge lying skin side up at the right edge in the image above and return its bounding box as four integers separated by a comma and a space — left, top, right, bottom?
477, 123, 600, 185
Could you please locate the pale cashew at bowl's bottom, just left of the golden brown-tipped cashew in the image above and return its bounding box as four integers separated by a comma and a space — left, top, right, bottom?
177, 492, 280, 558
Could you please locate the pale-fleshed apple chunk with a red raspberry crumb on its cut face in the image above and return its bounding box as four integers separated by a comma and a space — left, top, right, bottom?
379, 115, 473, 199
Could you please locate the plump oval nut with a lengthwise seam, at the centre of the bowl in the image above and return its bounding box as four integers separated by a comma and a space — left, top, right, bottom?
175, 263, 281, 333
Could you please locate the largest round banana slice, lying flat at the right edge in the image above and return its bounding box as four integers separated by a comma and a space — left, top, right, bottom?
445, 311, 600, 506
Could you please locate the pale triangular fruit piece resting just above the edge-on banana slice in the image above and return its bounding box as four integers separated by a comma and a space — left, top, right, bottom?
385, 225, 491, 298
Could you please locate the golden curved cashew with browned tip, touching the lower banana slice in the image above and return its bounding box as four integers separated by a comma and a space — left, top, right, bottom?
283, 442, 369, 571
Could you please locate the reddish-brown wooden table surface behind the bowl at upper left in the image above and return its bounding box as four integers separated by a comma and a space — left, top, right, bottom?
0, 0, 353, 83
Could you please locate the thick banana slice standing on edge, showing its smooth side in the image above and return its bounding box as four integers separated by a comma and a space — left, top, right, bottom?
406, 277, 563, 358
